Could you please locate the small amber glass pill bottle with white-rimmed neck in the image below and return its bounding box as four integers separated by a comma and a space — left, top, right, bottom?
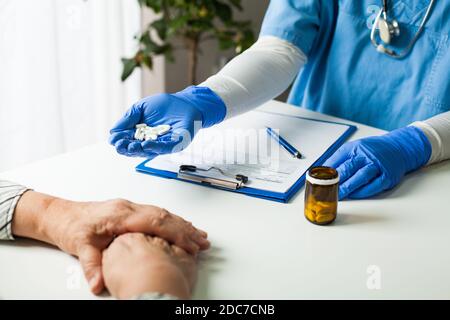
305, 167, 339, 225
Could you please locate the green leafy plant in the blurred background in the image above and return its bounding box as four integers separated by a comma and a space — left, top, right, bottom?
122, 0, 254, 84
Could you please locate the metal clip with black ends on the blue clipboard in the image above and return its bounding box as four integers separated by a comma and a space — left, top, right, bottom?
178, 165, 248, 190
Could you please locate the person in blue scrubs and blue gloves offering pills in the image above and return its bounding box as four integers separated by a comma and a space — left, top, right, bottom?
110, 0, 450, 199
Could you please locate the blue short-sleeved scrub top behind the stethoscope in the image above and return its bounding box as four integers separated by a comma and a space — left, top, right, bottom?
261, 0, 450, 130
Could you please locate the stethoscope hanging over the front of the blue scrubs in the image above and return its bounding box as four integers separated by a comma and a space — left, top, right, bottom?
370, 0, 435, 59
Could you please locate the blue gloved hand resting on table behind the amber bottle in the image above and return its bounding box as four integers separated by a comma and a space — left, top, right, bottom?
324, 126, 431, 200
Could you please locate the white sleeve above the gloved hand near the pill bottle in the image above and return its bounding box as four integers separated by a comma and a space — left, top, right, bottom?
412, 111, 450, 164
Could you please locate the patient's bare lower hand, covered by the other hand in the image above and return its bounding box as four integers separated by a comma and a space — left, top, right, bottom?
103, 233, 197, 299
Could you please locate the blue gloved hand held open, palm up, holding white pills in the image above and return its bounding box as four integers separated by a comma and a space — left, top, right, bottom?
109, 86, 226, 158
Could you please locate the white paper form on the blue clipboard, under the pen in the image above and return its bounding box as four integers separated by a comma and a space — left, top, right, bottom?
145, 110, 349, 193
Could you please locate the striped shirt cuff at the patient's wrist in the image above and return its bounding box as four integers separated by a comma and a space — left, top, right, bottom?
0, 180, 28, 240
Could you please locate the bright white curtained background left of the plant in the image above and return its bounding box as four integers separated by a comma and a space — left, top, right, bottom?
0, 0, 141, 171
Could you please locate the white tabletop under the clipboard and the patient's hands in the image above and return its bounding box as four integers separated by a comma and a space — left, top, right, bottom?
0, 102, 450, 299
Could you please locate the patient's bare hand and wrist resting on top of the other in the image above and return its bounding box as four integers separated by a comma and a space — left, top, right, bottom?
12, 191, 210, 293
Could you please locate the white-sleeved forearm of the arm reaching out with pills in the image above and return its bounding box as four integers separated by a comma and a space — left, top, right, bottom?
200, 36, 306, 118
